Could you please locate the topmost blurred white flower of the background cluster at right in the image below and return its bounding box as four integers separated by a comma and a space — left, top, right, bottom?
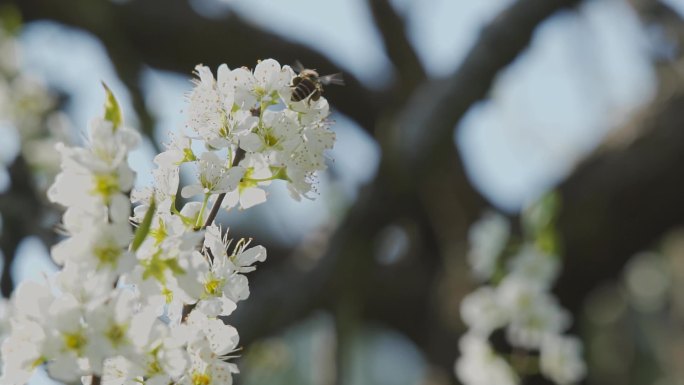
468, 211, 510, 280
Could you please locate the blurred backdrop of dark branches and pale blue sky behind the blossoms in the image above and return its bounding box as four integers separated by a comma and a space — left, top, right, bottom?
0, 0, 684, 385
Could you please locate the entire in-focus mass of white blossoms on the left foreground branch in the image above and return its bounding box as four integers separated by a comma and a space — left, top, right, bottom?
0, 60, 334, 385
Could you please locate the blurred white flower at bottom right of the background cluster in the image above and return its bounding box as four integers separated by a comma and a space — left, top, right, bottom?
540, 335, 587, 385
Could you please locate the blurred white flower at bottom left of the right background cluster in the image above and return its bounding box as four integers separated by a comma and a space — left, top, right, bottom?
455, 334, 519, 385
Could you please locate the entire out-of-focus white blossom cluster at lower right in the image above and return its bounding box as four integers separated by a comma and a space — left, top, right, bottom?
456, 202, 586, 385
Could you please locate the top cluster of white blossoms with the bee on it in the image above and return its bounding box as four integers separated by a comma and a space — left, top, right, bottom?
176, 59, 335, 208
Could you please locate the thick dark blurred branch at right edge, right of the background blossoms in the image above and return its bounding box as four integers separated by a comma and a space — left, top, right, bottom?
558, 94, 684, 311
